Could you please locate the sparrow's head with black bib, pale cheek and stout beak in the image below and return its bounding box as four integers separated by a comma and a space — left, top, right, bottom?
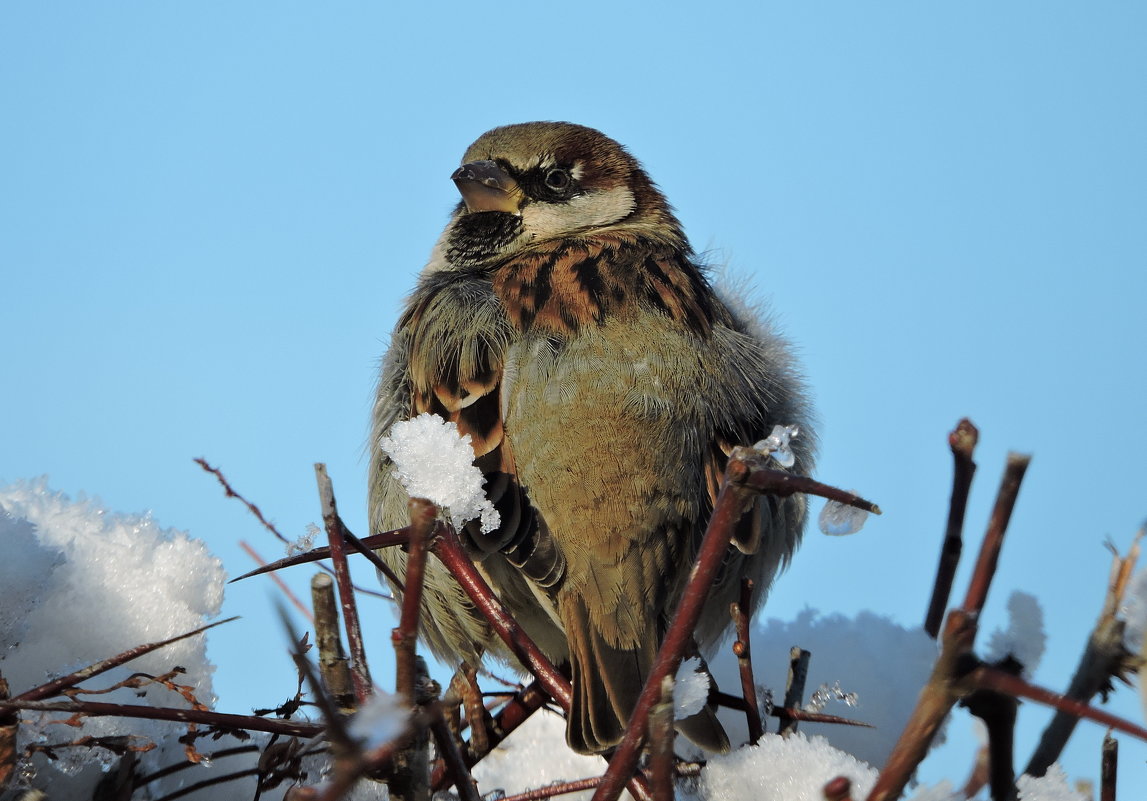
433, 123, 688, 266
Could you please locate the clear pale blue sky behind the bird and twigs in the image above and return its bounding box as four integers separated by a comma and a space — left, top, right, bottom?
0, 2, 1147, 792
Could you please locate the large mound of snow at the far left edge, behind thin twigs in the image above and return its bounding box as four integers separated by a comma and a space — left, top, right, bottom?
0, 479, 225, 798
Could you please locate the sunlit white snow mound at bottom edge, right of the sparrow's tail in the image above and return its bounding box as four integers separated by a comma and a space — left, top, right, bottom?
699, 732, 876, 801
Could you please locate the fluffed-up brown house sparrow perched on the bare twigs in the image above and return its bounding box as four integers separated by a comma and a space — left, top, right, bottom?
369, 123, 814, 753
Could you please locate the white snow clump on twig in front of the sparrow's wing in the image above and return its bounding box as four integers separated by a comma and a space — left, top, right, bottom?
379, 414, 501, 532
